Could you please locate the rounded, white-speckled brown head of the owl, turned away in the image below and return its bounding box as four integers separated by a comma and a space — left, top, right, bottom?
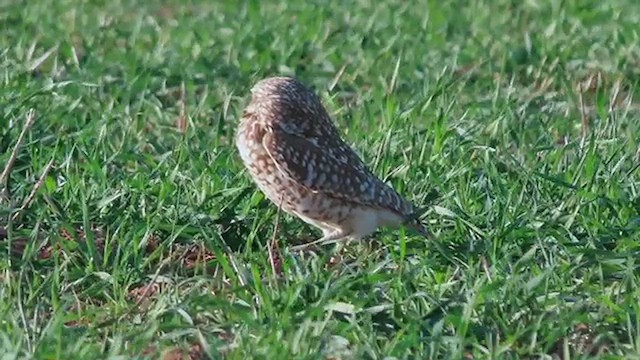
245, 77, 333, 136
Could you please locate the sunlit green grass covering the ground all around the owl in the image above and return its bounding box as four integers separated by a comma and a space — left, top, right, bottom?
0, 0, 640, 359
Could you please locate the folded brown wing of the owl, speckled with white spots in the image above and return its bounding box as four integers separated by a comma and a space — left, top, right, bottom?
262, 129, 411, 215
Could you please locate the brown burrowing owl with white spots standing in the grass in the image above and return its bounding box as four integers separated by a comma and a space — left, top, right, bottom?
236, 77, 429, 250
